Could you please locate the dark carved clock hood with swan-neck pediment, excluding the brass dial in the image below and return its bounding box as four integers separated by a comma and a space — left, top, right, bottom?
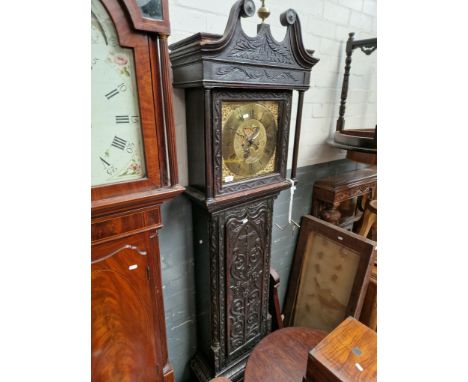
169, 0, 319, 210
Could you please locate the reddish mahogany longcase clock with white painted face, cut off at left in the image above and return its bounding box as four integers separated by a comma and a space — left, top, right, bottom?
91, 0, 183, 382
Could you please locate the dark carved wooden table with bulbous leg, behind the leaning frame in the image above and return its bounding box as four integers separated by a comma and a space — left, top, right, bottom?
311, 166, 377, 230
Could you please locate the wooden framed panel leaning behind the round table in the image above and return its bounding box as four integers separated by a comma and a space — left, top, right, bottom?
284, 215, 376, 332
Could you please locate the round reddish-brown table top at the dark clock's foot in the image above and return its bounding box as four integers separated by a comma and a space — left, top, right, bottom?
244, 327, 327, 382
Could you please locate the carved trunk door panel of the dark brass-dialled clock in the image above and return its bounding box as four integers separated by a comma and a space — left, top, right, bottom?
225, 200, 271, 360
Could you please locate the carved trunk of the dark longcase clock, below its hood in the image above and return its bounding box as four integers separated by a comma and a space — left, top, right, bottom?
191, 196, 274, 381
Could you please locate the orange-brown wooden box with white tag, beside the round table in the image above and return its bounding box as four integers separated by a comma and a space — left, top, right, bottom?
304, 317, 377, 382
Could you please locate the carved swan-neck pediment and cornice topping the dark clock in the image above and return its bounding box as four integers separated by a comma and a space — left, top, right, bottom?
169, 0, 319, 90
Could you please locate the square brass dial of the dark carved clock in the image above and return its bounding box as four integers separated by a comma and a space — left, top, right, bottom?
222, 101, 278, 183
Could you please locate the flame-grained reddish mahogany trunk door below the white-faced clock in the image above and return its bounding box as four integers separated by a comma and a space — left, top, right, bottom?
91, 234, 162, 382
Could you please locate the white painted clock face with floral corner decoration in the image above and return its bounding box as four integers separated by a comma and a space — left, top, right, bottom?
91, 0, 145, 186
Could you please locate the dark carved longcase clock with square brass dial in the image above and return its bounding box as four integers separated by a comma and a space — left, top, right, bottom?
170, 0, 318, 381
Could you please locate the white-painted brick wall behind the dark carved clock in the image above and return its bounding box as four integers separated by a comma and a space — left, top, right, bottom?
169, 0, 377, 185
